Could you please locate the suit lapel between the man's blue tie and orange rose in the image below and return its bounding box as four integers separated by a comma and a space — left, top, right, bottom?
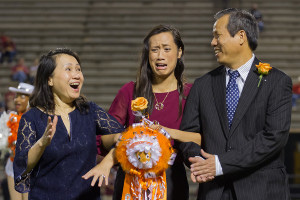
229, 58, 259, 137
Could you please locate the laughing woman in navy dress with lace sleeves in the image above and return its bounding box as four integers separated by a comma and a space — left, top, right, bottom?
14, 49, 123, 200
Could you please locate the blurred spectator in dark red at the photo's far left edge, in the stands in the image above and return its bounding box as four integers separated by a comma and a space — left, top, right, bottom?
0, 34, 17, 63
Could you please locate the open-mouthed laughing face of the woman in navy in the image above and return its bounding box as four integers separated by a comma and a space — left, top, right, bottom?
48, 54, 84, 103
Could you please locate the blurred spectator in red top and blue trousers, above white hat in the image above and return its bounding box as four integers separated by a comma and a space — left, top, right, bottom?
11, 58, 29, 82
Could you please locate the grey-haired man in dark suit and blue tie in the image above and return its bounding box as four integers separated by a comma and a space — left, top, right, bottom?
180, 8, 292, 200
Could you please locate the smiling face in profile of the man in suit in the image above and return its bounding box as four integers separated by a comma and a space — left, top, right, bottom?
211, 15, 241, 68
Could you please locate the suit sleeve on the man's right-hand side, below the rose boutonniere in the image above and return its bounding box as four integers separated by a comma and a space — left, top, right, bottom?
218, 75, 292, 174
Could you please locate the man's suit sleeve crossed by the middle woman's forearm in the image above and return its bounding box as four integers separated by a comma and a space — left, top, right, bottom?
178, 81, 201, 167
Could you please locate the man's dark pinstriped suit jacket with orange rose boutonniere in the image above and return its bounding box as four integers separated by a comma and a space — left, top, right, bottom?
180, 58, 292, 200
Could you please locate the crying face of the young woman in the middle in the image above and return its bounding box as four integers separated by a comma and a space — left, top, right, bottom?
149, 32, 182, 77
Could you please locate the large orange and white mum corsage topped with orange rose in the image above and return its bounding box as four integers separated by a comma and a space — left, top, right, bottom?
116, 97, 176, 200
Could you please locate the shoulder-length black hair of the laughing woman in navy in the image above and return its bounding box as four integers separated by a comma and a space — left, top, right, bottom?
29, 48, 89, 113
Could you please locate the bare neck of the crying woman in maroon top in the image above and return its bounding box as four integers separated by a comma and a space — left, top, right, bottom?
152, 76, 177, 93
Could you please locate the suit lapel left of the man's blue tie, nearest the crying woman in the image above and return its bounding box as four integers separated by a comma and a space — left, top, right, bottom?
212, 66, 229, 138
